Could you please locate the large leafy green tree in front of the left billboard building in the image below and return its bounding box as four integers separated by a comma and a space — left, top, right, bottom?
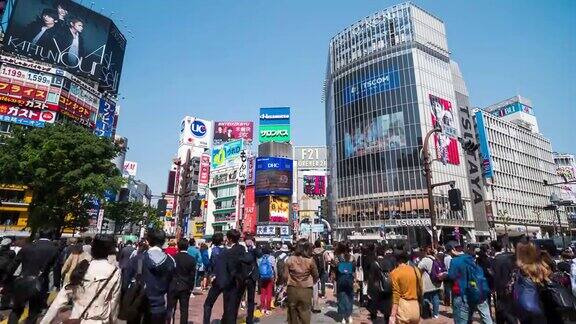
0, 123, 124, 235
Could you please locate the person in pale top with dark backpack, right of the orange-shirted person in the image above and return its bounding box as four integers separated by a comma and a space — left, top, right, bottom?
418, 246, 448, 318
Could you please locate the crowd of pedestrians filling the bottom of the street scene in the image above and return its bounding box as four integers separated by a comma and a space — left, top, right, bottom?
0, 229, 576, 324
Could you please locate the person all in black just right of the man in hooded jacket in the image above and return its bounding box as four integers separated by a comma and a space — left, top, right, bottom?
168, 239, 196, 324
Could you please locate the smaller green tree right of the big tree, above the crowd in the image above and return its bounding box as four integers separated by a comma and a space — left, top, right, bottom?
104, 201, 162, 234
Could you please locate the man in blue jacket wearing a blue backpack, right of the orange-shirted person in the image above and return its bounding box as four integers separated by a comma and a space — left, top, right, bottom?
448, 243, 492, 324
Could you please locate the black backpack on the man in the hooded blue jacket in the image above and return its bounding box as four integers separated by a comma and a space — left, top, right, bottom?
118, 255, 146, 322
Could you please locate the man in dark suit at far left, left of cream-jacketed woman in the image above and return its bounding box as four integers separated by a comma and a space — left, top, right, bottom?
8, 230, 58, 324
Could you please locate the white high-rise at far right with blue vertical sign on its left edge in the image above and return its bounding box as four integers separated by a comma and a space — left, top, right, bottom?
475, 96, 567, 237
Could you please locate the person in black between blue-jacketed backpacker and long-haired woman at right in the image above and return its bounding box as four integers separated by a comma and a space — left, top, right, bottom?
490, 241, 518, 324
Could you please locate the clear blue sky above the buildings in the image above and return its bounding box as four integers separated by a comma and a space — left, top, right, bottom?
90, 0, 576, 194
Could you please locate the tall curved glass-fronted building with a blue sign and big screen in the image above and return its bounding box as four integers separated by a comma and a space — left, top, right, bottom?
325, 3, 474, 245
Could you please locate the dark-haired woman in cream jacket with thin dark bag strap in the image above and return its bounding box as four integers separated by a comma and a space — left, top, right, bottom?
40, 234, 121, 324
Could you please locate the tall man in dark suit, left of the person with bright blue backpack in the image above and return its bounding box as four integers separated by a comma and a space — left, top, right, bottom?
222, 229, 247, 324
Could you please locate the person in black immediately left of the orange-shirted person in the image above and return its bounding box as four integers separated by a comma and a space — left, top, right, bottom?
366, 246, 396, 322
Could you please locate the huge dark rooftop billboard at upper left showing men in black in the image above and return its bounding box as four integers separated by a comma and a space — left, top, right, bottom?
3, 0, 126, 93
